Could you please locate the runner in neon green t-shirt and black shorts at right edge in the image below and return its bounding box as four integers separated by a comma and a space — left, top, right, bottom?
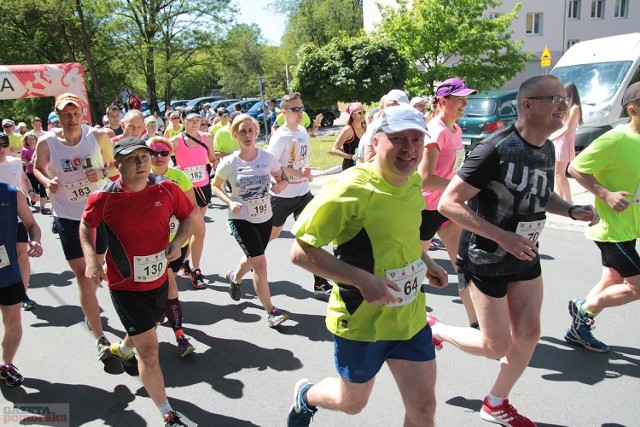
564, 83, 640, 352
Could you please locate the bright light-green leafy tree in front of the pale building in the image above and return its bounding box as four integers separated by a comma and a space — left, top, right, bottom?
379, 0, 531, 93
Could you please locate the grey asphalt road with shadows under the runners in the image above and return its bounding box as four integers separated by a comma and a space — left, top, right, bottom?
0, 178, 640, 427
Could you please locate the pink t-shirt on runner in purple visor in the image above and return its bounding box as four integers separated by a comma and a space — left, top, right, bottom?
422, 117, 464, 211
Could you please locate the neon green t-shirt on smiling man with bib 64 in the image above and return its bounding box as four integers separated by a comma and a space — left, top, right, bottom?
292, 163, 426, 342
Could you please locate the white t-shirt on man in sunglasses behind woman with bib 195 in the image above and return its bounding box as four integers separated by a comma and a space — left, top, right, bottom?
268, 126, 310, 199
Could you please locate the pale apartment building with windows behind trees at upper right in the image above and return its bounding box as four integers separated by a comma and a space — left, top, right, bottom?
363, 0, 640, 88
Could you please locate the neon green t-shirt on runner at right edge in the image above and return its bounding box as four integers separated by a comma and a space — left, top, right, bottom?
571, 125, 640, 242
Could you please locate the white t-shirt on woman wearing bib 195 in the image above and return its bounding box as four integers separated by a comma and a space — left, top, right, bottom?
216, 148, 282, 224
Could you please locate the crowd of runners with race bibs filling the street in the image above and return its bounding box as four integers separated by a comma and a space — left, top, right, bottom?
0, 75, 640, 426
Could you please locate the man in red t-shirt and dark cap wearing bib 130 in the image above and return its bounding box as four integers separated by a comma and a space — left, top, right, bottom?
80, 137, 194, 427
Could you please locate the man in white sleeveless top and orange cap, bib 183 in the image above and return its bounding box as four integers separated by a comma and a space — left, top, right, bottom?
34, 93, 113, 360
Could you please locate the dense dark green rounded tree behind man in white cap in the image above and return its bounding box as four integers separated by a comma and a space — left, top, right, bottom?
292, 36, 409, 105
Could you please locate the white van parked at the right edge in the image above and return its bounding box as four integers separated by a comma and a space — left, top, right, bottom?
551, 32, 640, 151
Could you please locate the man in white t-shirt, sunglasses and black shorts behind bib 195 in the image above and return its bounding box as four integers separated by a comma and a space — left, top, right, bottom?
268, 92, 331, 295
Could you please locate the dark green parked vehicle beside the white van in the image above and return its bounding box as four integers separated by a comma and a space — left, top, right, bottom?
458, 89, 518, 151
